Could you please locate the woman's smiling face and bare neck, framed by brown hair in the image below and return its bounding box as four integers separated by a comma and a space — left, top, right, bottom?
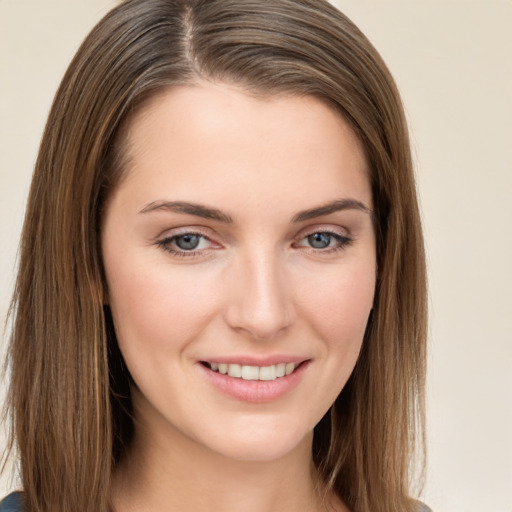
102, 83, 376, 512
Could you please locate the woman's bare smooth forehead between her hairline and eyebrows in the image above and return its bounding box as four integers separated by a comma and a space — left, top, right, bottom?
114, 83, 371, 216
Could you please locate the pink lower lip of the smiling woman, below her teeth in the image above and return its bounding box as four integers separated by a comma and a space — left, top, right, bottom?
198, 361, 310, 403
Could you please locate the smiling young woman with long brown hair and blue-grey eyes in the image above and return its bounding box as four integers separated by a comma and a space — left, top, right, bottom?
0, 0, 426, 512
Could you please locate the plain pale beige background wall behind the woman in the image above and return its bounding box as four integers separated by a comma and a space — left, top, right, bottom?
0, 0, 512, 512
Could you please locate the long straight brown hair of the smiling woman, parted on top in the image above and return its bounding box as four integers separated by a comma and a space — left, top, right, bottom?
4, 0, 426, 512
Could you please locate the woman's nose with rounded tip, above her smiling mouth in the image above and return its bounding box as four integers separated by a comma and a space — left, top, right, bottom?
225, 249, 295, 340
